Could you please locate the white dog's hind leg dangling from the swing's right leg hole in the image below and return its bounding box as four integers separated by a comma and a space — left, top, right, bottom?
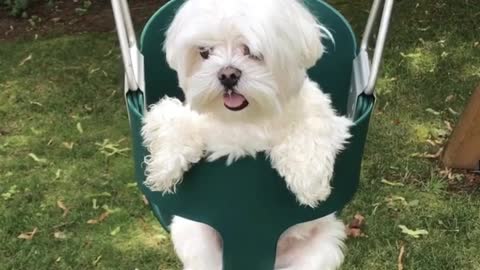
275, 215, 346, 270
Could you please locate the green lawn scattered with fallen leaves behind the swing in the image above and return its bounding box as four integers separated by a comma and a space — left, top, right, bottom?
0, 0, 480, 270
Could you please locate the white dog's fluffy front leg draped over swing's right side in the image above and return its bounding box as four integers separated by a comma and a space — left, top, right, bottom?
270, 84, 351, 207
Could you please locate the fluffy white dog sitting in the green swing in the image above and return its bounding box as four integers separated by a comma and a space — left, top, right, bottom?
143, 0, 351, 270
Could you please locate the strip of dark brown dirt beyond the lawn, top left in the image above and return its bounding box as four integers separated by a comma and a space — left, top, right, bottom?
0, 0, 168, 41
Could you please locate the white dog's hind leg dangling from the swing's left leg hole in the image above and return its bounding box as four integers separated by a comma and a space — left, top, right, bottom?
171, 217, 222, 270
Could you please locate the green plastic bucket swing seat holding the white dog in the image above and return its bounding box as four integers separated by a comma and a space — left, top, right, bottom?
112, 0, 389, 270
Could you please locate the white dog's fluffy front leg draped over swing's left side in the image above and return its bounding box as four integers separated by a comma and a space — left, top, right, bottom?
142, 98, 203, 192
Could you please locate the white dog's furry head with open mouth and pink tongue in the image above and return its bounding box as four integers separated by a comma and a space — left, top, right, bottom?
165, 0, 323, 119
